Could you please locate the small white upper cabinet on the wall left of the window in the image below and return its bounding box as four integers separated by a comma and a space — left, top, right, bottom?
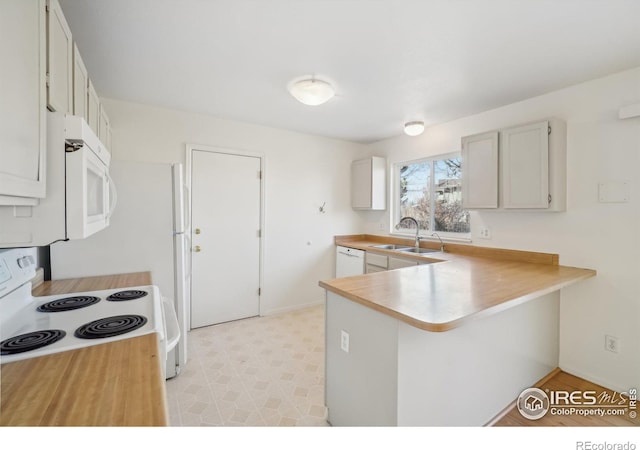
351, 156, 387, 210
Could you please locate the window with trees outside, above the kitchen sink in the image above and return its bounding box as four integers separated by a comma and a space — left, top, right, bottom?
394, 155, 470, 237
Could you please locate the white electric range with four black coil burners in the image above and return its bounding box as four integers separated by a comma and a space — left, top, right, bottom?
0, 248, 179, 368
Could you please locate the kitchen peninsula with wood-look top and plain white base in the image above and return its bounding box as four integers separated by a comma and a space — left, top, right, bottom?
320, 235, 596, 426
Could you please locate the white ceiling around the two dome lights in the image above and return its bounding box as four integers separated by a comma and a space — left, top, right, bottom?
60, 0, 640, 142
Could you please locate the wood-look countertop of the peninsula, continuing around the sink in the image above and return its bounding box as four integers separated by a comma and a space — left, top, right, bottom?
319, 235, 596, 331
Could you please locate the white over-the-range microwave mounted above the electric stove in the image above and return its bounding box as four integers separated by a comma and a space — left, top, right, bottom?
0, 111, 117, 248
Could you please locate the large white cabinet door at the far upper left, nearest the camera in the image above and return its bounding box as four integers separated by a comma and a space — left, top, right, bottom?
0, 0, 46, 200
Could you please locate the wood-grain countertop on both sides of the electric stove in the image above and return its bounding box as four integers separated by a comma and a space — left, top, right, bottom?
0, 272, 168, 426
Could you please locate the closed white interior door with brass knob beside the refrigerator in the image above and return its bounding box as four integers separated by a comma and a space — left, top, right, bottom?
191, 149, 261, 328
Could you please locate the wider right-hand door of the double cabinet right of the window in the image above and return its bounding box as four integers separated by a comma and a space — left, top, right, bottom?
500, 121, 550, 209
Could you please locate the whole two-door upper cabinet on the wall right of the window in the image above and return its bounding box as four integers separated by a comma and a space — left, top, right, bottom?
462, 119, 567, 211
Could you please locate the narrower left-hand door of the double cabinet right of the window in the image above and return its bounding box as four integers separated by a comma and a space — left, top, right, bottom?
462, 131, 498, 209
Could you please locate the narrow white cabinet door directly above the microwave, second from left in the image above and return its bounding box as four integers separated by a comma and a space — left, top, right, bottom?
47, 0, 73, 114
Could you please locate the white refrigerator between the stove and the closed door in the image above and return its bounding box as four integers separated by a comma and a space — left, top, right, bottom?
51, 161, 191, 378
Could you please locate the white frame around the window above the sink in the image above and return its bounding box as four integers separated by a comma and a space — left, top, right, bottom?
389, 151, 471, 242
